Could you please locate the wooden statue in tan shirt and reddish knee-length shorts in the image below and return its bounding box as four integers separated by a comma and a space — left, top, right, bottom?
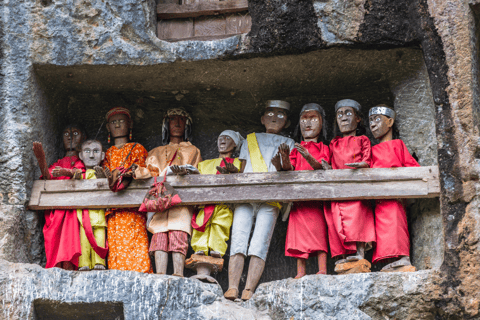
135, 108, 202, 277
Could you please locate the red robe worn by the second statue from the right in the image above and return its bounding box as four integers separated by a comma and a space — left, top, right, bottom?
325, 136, 375, 257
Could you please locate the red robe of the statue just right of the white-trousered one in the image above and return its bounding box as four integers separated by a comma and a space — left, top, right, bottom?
285, 141, 330, 259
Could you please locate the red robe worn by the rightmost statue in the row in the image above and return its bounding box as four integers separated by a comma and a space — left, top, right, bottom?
372, 140, 420, 263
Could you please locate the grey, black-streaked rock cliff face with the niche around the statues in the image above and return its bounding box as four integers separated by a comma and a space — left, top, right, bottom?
0, 0, 480, 319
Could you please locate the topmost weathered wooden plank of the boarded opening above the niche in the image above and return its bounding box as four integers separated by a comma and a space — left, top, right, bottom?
157, 0, 248, 19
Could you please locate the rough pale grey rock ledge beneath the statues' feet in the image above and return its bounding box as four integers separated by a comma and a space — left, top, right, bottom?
0, 260, 439, 320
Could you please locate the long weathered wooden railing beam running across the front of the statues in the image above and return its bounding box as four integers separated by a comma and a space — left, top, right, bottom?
25, 167, 440, 210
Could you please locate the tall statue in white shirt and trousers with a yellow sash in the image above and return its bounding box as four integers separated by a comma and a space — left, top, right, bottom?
225, 100, 295, 300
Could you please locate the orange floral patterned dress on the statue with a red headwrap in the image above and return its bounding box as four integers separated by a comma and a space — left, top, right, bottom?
104, 143, 152, 273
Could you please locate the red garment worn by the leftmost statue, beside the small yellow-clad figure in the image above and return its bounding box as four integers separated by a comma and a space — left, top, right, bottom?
43, 156, 85, 268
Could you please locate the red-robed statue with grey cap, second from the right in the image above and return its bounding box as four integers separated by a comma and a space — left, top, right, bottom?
325, 99, 375, 273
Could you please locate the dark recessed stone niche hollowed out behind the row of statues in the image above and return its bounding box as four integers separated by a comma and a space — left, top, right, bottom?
31, 47, 444, 290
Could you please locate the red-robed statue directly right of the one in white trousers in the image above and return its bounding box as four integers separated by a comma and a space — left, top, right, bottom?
272, 103, 330, 279
